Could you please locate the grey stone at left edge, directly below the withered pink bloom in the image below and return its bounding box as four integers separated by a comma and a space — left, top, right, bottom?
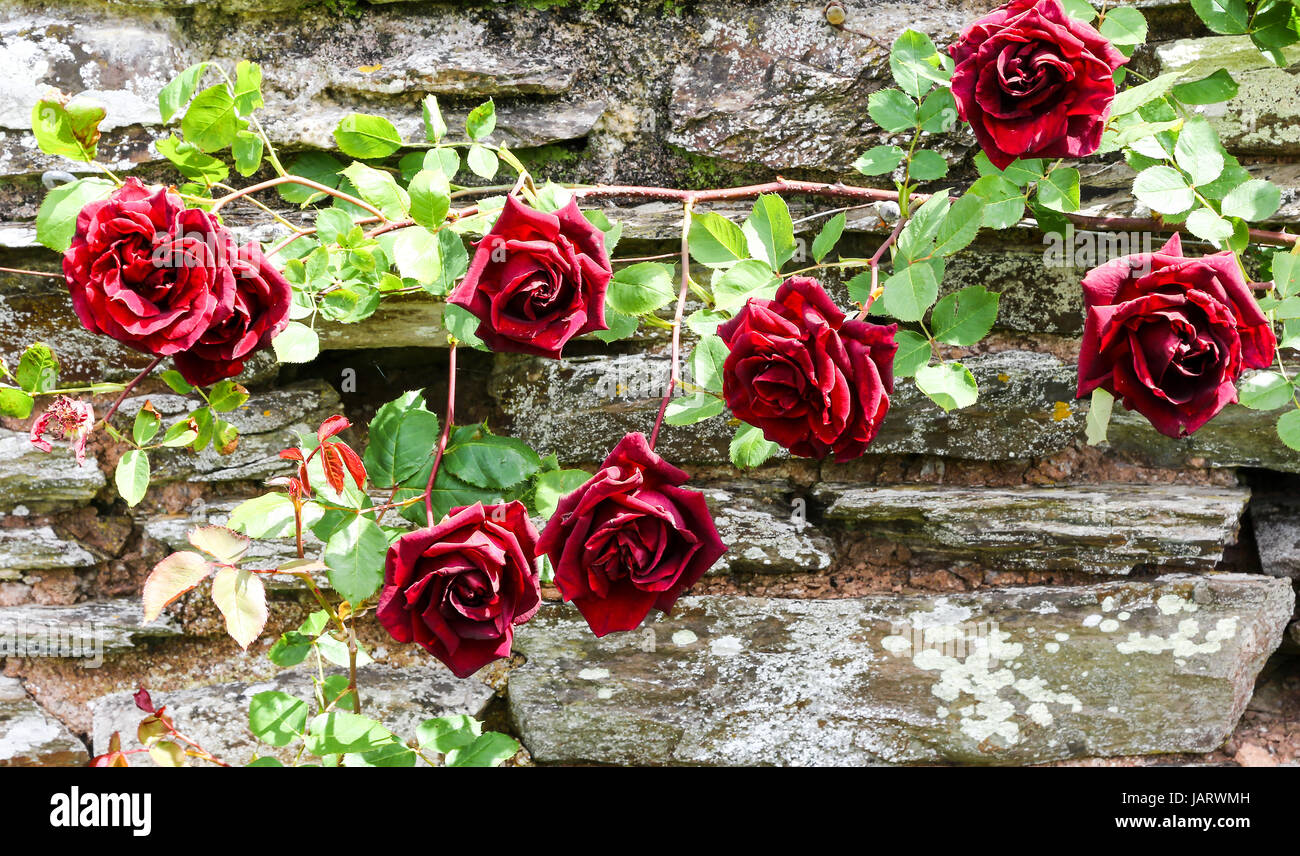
0, 428, 105, 510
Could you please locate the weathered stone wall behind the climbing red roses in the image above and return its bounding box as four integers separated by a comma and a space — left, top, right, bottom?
0, 0, 1300, 765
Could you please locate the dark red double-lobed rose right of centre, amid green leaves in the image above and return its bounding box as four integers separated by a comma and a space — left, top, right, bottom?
718, 277, 898, 461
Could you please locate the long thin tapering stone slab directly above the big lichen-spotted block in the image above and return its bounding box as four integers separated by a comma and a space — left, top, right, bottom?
814, 484, 1251, 574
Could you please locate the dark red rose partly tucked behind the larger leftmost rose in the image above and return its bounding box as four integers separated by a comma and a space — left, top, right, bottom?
176, 242, 294, 386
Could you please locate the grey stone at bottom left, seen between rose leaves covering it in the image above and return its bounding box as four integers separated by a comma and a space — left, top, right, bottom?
91, 666, 493, 766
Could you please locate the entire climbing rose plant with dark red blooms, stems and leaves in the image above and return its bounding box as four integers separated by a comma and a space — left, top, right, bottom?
0, 0, 1300, 766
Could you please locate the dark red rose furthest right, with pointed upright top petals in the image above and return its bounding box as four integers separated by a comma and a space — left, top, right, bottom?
1079, 234, 1277, 437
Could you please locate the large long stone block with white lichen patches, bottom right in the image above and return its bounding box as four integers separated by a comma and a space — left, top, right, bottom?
510, 575, 1295, 765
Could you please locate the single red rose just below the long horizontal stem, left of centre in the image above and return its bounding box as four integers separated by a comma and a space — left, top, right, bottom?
450, 196, 614, 359
